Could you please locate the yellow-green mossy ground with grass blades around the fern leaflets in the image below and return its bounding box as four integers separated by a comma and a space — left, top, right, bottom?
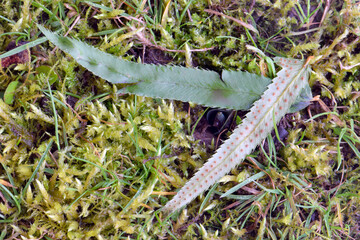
0, 0, 360, 239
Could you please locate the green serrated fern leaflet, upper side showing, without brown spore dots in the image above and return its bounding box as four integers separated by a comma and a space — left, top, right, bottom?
38, 25, 271, 110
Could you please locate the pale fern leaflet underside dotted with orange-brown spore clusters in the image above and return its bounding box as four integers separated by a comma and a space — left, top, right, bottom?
163, 57, 311, 212
